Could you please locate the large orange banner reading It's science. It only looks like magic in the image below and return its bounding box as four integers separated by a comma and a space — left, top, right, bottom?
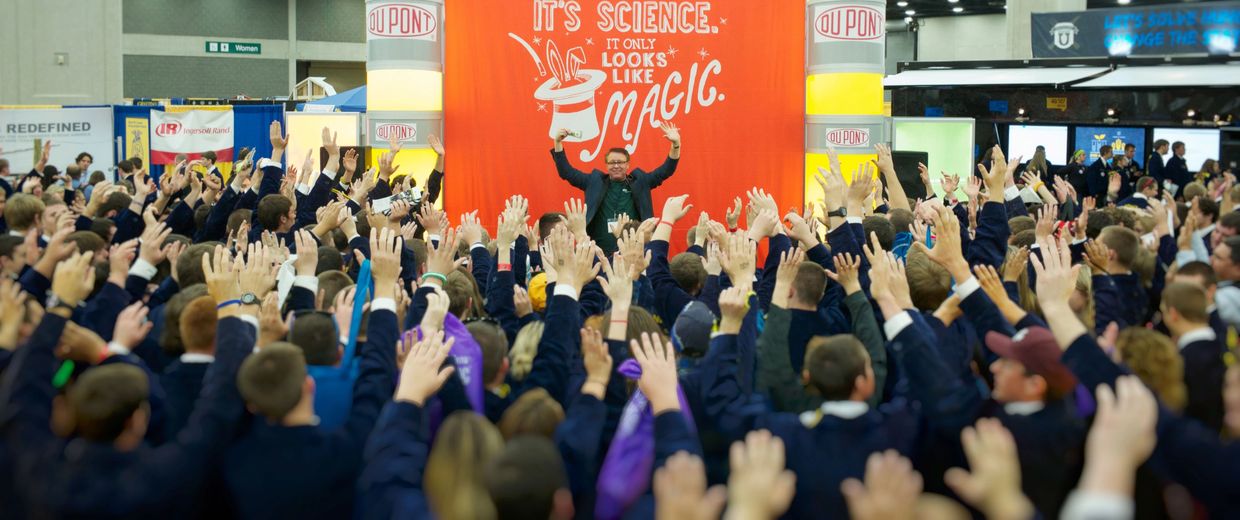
444, 0, 805, 235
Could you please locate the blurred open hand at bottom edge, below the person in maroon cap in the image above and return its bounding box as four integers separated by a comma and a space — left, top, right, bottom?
944, 418, 1033, 519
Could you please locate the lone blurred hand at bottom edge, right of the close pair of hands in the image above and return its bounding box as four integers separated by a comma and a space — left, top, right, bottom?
839, 449, 921, 520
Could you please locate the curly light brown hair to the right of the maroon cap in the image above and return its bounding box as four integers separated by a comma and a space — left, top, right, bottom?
1115, 326, 1188, 412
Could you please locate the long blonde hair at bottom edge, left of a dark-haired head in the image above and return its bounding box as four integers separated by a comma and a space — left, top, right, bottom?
423, 411, 503, 520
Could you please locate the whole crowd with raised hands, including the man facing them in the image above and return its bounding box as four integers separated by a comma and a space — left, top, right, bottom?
0, 117, 1240, 520
